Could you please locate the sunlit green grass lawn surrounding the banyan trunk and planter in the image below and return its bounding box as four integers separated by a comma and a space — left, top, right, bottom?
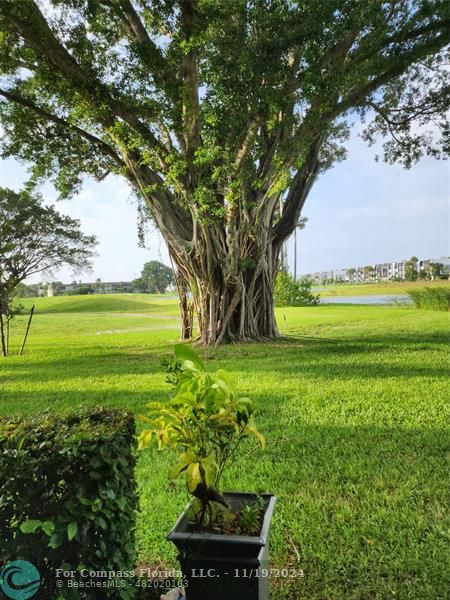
0, 295, 450, 600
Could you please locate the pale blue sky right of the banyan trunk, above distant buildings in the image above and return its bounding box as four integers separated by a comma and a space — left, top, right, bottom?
289, 128, 450, 273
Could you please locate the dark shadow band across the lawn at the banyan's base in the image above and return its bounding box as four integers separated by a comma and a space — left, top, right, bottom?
2, 334, 448, 385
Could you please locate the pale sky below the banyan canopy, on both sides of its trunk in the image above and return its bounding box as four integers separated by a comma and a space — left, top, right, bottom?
0, 127, 450, 282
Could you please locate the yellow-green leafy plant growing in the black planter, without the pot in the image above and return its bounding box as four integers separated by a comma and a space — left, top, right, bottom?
139, 344, 265, 524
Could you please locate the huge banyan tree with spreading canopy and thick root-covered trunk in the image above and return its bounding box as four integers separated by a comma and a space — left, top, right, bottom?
0, 0, 449, 344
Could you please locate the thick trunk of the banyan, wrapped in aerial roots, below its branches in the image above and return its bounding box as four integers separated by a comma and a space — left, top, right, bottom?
171, 232, 279, 345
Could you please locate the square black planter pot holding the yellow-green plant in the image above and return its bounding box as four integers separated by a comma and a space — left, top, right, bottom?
167, 492, 276, 600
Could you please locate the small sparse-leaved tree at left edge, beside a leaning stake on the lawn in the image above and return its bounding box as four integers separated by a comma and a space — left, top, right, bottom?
0, 188, 96, 356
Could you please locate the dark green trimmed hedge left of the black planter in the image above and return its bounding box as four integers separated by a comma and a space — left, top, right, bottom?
0, 409, 137, 600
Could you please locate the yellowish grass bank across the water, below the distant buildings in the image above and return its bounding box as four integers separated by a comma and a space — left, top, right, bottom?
318, 280, 450, 298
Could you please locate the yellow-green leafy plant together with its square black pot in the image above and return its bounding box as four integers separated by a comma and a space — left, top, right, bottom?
139, 344, 275, 600
